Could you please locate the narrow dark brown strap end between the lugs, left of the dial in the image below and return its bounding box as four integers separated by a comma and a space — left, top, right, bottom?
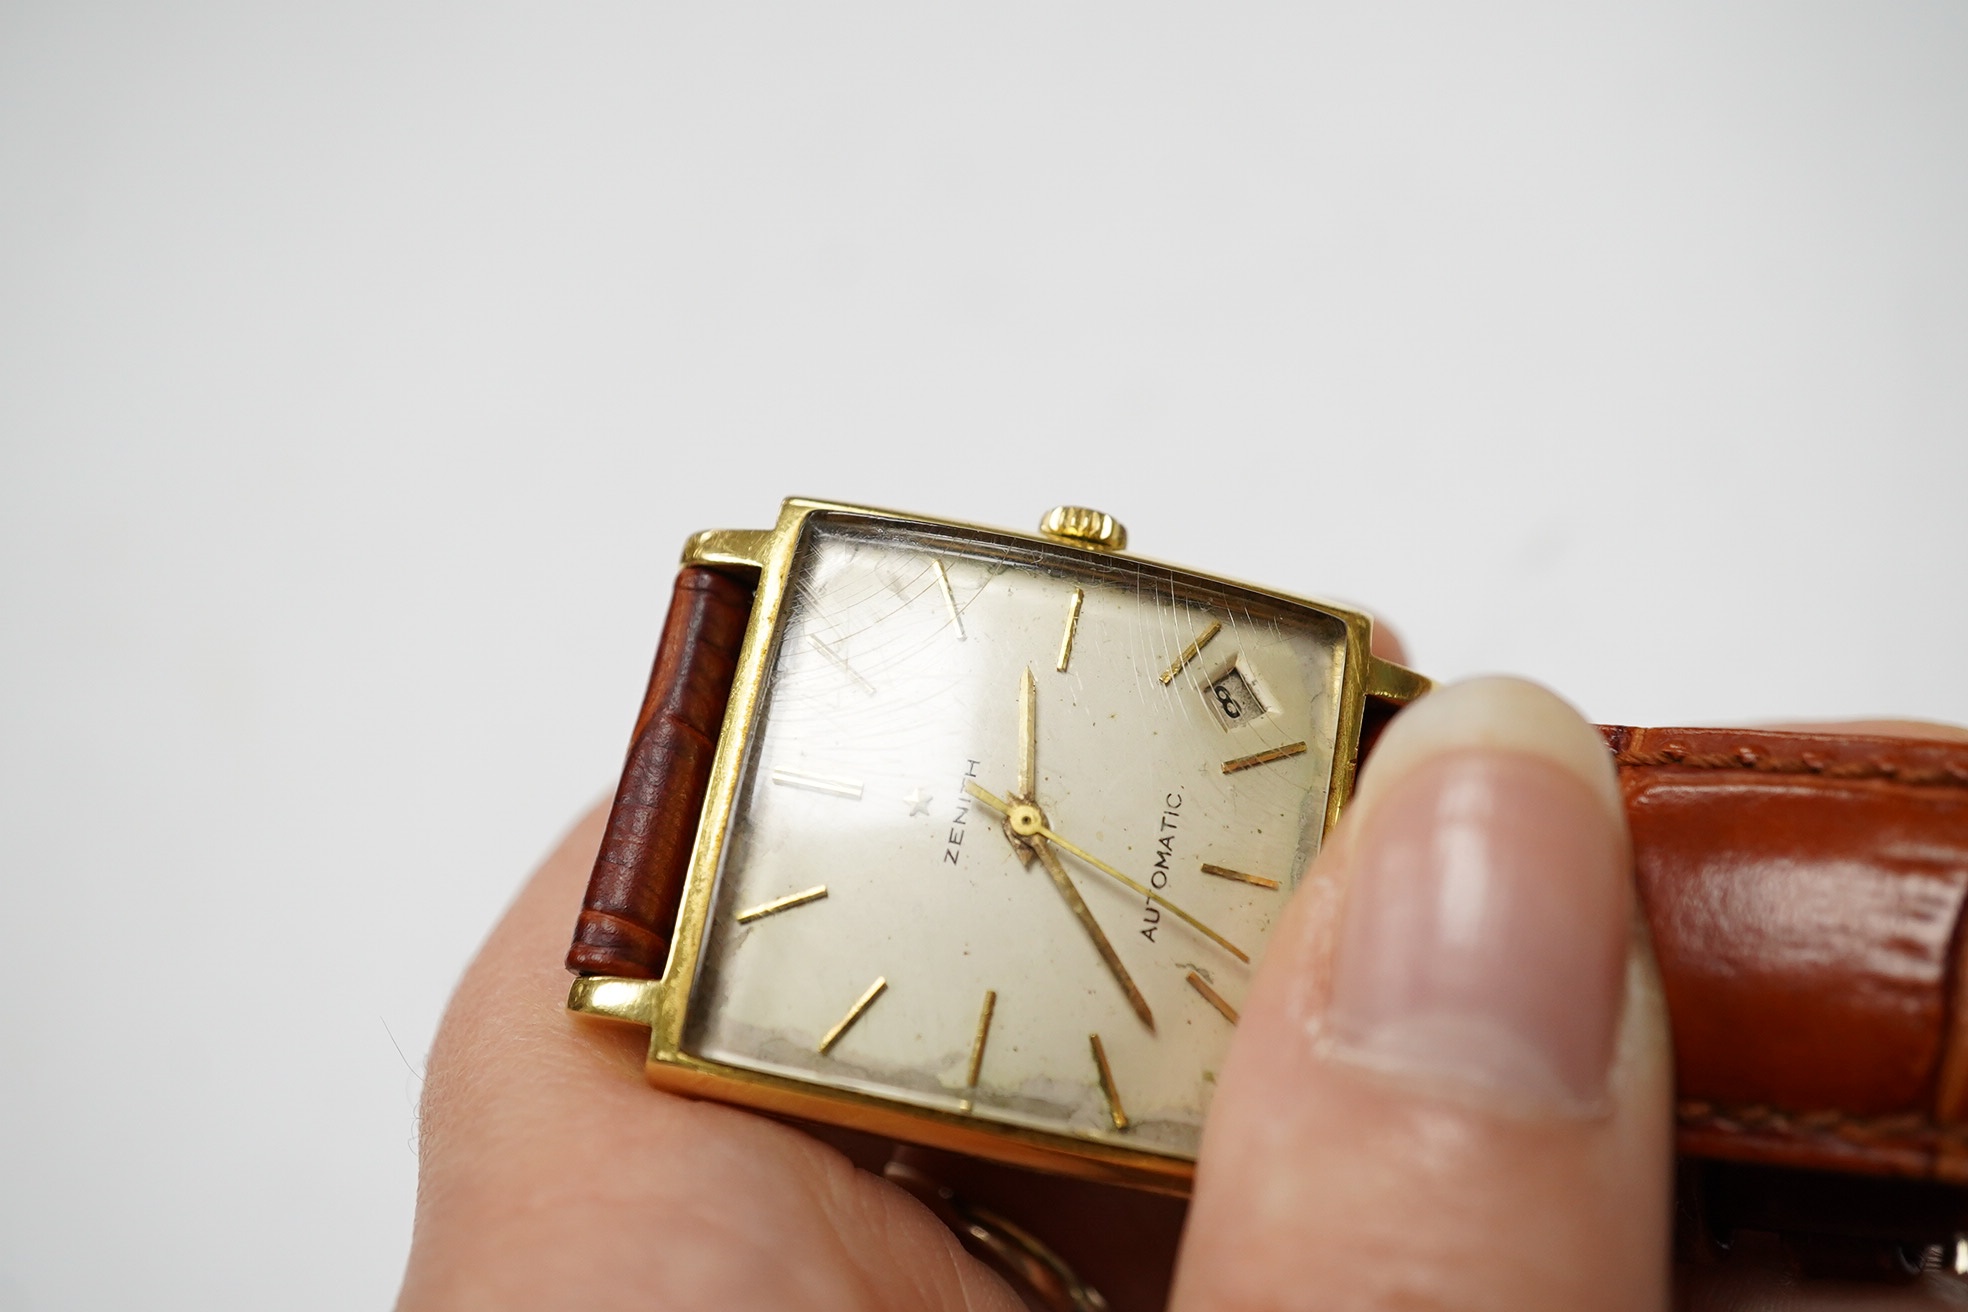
567, 565, 752, 980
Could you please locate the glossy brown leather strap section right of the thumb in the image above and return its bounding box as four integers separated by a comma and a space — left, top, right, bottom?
1604, 728, 1968, 1184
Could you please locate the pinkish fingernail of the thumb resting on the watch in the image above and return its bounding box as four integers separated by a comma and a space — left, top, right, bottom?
1324, 679, 1631, 1115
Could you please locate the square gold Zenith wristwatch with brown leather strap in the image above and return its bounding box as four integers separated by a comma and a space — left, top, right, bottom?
567, 500, 1968, 1243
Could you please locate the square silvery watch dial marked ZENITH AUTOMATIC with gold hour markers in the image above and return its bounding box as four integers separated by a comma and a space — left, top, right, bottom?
683, 517, 1346, 1157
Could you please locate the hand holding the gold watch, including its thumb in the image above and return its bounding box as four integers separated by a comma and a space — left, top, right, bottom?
400, 681, 1958, 1312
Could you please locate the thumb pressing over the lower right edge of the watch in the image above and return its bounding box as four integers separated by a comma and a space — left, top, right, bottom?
1173, 679, 1673, 1312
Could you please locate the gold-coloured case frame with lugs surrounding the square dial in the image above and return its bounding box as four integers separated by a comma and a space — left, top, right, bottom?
567, 498, 1429, 1194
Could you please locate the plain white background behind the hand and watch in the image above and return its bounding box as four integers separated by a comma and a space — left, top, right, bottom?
0, 0, 1968, 1312
